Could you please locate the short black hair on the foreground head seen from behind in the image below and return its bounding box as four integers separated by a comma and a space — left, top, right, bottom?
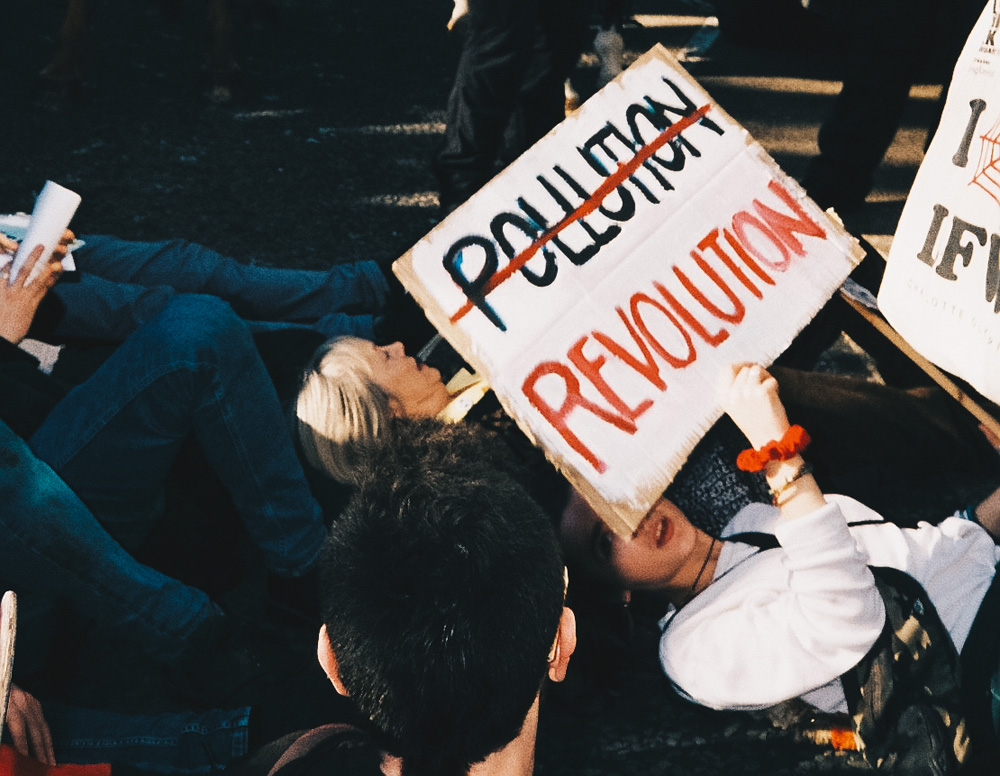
320, 420, 563, 776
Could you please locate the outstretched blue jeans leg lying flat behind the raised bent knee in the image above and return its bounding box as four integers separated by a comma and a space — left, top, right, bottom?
54, 235, 389, 339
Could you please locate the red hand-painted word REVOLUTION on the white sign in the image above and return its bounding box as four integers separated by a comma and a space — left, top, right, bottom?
521, 181, 826, 472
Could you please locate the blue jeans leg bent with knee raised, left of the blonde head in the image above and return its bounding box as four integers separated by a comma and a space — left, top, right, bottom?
30, 294, 325, 576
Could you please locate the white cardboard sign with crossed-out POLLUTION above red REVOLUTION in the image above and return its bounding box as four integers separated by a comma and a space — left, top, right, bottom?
394, 47, 859, 534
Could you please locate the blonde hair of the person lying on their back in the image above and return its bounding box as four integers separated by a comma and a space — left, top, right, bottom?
295, 337, 393, 483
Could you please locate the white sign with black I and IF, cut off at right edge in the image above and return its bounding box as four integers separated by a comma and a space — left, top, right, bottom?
878, 3, 1000, 402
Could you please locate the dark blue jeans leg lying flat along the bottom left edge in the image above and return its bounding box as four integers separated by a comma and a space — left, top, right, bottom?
42, 703, 250, 774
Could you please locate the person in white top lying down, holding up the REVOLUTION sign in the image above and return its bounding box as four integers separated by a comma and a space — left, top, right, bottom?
561, 365, 1000, 764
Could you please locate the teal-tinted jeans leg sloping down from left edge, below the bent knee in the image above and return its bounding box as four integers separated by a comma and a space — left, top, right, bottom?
0, 424, 220, 670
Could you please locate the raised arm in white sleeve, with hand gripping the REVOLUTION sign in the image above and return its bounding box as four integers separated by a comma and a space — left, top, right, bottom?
660, 365, 885, 710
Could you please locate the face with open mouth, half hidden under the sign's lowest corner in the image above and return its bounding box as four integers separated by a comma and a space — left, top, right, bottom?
559, 491, 699, 590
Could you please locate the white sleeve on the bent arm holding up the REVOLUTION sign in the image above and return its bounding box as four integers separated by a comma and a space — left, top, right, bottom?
660, 502, 885, 709
